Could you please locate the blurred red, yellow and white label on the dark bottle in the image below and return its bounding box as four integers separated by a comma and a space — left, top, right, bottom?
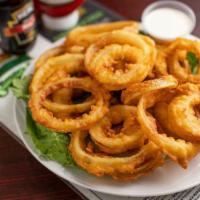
3, 2, 36, 46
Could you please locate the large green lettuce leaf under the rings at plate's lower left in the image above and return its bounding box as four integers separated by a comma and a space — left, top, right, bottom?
25, 109, 75, 167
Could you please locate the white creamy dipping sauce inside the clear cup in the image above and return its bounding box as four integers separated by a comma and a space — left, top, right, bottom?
143, 7, 193, 39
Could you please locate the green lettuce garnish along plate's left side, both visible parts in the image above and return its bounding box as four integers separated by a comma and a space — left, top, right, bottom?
12, 76, 75, 167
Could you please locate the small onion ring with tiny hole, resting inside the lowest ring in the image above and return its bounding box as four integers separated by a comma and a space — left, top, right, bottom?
89, 105, 145, 154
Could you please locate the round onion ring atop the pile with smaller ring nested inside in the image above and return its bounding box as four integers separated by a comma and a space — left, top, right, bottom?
85, 30, 156, 90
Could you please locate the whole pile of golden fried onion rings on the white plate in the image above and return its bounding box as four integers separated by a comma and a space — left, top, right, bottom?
29, 21, 200, 180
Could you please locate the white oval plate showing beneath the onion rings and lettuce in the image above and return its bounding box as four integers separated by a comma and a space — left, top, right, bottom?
13, 34, 200, 197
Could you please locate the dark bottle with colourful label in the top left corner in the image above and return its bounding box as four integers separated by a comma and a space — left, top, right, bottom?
0, 0, 36, 54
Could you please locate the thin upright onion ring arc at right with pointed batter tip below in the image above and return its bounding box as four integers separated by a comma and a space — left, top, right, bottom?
138, 90, 200, 168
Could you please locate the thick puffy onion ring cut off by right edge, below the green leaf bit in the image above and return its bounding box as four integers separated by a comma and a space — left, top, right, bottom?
168, 88, 200, 142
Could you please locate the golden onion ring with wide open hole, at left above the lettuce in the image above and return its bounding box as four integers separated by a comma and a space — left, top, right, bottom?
29, 77, 109, 132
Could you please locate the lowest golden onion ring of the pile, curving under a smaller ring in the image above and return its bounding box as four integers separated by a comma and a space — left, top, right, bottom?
69, 131, 162, 179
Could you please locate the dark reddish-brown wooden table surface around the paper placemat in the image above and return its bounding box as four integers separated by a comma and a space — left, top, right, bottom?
0, 0, 200, 200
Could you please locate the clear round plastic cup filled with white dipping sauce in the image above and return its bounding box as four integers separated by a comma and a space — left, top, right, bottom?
141, 1, 196, 42
